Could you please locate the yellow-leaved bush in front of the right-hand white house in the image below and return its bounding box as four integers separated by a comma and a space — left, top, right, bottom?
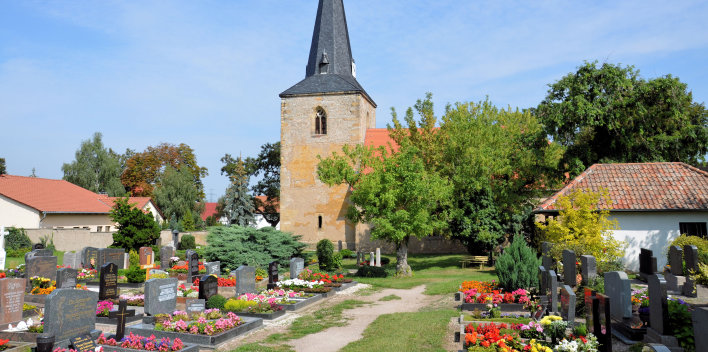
536, 190, 626, 266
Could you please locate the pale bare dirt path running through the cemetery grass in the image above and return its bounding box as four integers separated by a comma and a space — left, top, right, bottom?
288, 285, 432, 352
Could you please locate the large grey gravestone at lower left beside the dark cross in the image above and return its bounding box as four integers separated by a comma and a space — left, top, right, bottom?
44, 288, 98, 342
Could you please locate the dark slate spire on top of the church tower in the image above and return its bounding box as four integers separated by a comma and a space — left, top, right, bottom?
280, 0, 376, 107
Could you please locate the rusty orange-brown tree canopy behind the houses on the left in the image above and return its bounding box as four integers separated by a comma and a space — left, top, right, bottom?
121, 143, 209, 200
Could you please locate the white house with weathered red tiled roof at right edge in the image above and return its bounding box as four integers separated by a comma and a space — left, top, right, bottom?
534, 162, 708, 271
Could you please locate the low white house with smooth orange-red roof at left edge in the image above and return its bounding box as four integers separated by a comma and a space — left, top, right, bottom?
0, 175, 164, 232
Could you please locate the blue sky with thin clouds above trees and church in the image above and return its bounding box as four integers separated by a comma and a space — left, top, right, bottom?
0, 0, 708, 200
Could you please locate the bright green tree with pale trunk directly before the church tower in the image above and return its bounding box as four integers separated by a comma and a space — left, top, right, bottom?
317, 142, 452, 276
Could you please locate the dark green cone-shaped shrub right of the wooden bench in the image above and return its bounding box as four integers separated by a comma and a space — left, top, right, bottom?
495, 235, 540, 292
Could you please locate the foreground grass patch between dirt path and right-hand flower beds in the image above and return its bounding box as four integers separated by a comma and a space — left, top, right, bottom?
341, 309, 457, 352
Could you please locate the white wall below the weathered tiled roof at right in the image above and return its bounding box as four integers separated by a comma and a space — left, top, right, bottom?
610, 212, 708, 271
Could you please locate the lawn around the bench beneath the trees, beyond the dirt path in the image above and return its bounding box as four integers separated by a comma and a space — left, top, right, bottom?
343, 255, 496, 295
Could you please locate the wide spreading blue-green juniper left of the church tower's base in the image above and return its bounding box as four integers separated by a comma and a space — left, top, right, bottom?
204, 226, 305, 268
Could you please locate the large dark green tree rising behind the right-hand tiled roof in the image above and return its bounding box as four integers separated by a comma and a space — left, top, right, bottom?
536, 62, 708, 176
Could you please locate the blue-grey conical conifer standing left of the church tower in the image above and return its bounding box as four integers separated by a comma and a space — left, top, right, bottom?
224, 157, 256, 226
